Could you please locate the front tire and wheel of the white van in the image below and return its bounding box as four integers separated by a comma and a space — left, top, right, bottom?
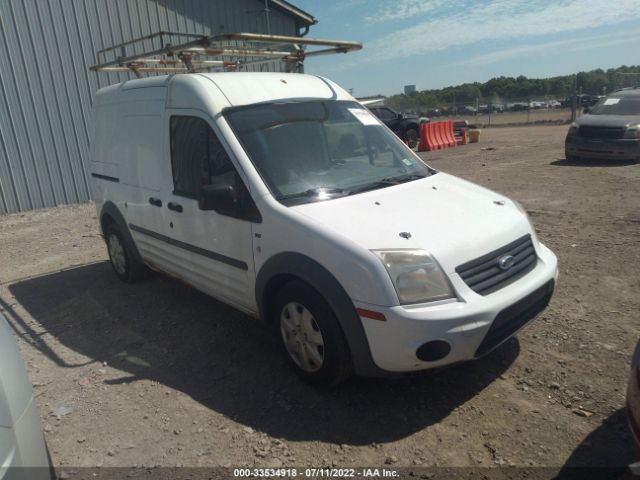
272, 281, 353, 388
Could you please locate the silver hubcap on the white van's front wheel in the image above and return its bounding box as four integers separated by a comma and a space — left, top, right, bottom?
280, 302, 324, 373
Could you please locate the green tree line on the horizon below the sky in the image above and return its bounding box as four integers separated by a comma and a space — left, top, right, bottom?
385, 65, 640, 110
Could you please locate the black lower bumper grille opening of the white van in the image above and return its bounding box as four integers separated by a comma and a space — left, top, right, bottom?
475, 280, 555, 357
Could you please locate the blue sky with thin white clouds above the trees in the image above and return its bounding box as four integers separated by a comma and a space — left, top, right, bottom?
292, 0, 640, 97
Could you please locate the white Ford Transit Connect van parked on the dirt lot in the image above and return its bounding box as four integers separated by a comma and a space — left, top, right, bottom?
91, 72, 557, 385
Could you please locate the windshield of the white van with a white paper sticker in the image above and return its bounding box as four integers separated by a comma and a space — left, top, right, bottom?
223, 100, 435, 205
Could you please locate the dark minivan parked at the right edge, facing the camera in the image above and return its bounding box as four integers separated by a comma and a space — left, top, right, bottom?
565, 89, 640, 161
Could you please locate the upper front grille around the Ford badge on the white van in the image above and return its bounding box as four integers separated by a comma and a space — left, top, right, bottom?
456, 235, 538, 295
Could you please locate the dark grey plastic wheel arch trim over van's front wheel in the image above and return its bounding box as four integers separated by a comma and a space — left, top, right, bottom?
256, 252, 386, 376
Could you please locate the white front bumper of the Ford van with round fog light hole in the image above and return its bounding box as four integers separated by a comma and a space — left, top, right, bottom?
355, 244, 558, 372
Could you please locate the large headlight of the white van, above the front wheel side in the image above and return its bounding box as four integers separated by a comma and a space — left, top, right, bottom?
373, 250, 455, 305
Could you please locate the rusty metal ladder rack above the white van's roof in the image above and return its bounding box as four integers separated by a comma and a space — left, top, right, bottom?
89, 31, 362, 77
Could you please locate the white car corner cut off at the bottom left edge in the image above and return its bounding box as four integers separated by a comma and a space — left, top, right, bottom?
0, 314, 54, 480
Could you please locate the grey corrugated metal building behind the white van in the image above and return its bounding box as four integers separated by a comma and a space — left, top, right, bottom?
0, 0, 315, 214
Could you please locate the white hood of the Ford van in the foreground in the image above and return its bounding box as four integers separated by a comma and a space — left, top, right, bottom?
291, 173, 531, 273
